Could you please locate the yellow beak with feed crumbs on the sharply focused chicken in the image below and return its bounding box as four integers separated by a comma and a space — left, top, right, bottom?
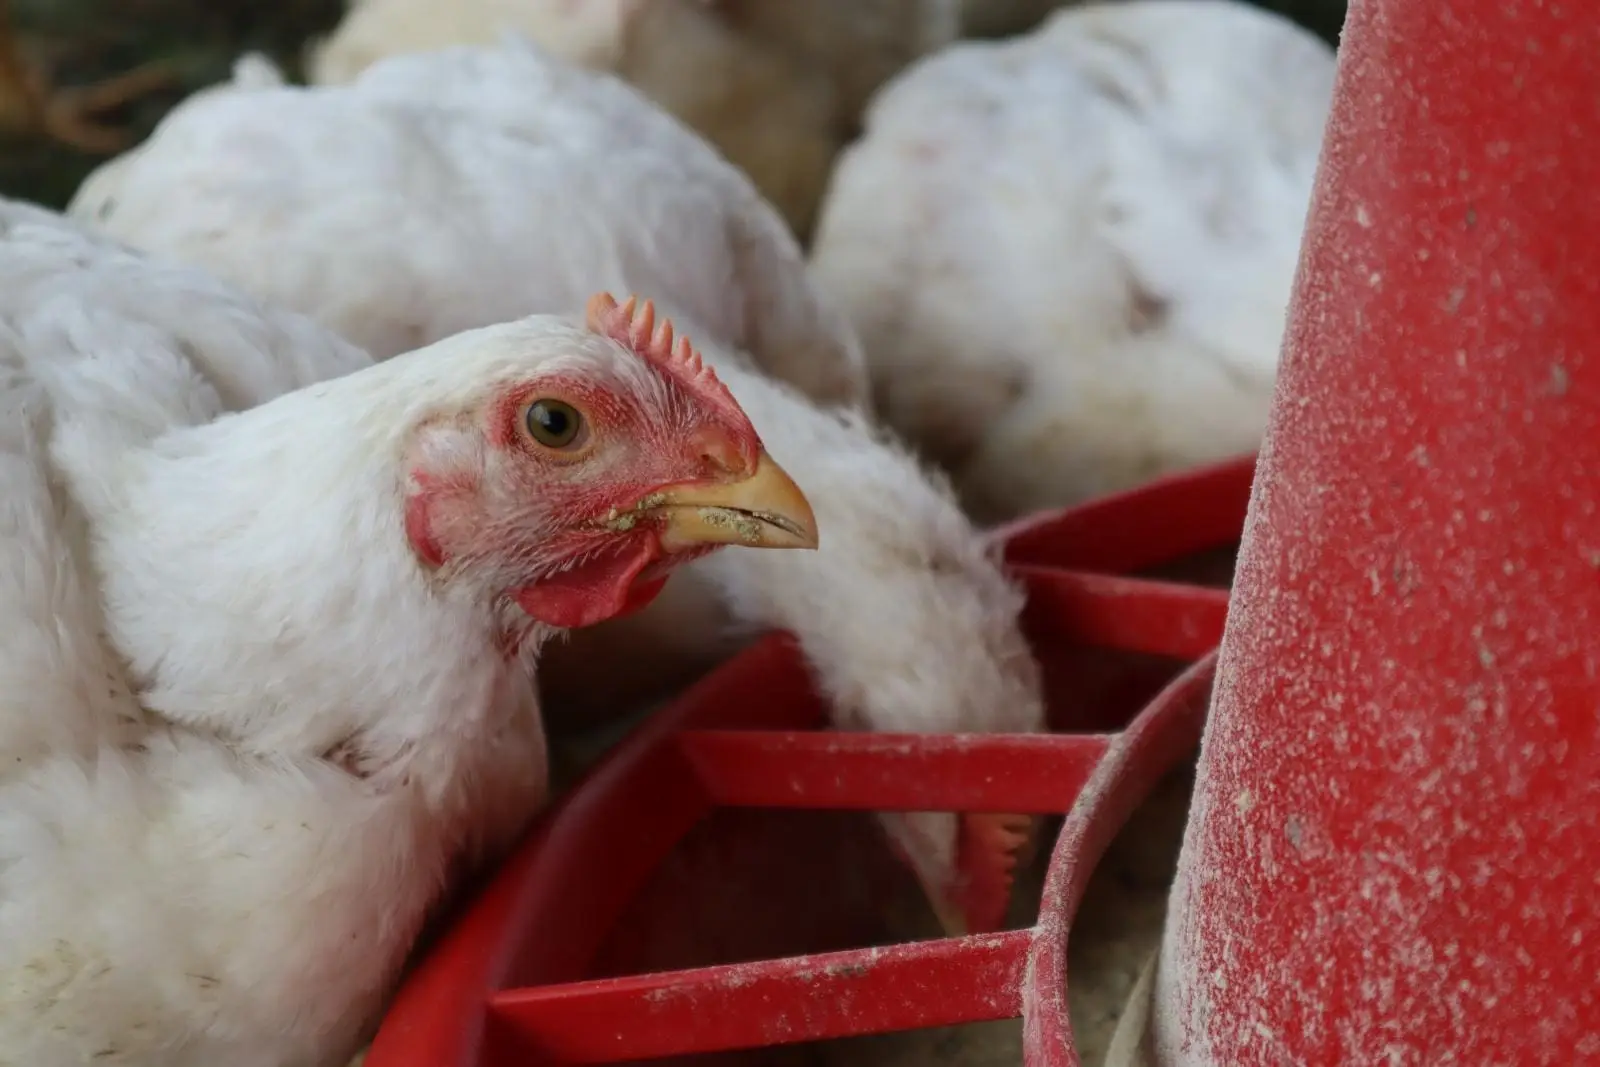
650, 451, 818, 552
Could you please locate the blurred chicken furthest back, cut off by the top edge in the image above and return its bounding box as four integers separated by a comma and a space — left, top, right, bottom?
307, 0, 960, 240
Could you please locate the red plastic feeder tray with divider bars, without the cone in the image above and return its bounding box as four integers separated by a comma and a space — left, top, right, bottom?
366, 459, 1254, 1067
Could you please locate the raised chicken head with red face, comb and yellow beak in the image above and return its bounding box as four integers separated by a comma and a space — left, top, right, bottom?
405, 293, 818, 640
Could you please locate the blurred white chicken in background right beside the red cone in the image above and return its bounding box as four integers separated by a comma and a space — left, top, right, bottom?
811, 0, 1334, 518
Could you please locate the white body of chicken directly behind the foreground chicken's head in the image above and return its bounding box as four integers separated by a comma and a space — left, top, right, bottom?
69, 43, 867, 402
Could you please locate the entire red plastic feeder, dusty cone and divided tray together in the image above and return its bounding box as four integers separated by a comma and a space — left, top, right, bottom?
368, 0, 1600, 1067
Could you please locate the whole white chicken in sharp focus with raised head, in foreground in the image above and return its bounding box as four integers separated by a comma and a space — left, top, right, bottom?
0, 203, 816, 1067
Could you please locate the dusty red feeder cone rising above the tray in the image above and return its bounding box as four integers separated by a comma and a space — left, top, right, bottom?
1149, 0, 1600, 1067
